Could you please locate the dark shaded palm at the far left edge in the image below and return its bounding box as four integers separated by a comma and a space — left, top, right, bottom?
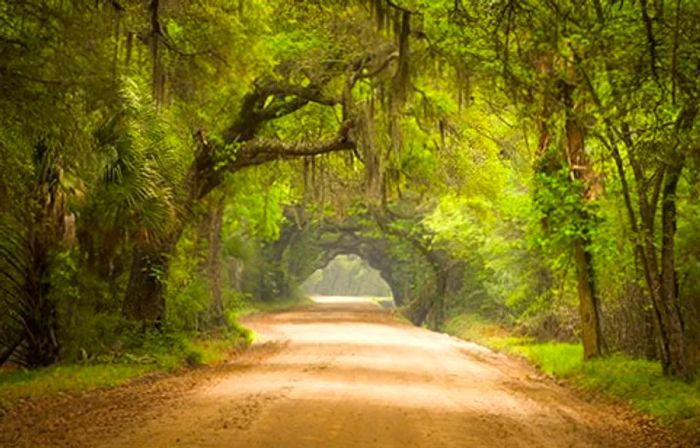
0, 140, 67, 367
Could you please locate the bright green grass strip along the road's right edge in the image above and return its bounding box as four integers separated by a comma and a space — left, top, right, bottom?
444, 315, 700, 437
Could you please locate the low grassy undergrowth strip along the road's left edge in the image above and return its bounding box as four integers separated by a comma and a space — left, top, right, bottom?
0, 298, 311, 409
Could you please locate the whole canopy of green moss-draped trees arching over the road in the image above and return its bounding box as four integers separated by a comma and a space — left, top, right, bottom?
0, 0, 700, 379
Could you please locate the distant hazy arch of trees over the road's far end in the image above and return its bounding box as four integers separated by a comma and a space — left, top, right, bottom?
257, 210, 466, 327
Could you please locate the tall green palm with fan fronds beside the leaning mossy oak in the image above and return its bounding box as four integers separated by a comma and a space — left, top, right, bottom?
83, 79, 189, 272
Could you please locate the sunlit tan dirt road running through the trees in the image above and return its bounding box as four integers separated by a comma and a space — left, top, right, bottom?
0, 298, 692, 448
